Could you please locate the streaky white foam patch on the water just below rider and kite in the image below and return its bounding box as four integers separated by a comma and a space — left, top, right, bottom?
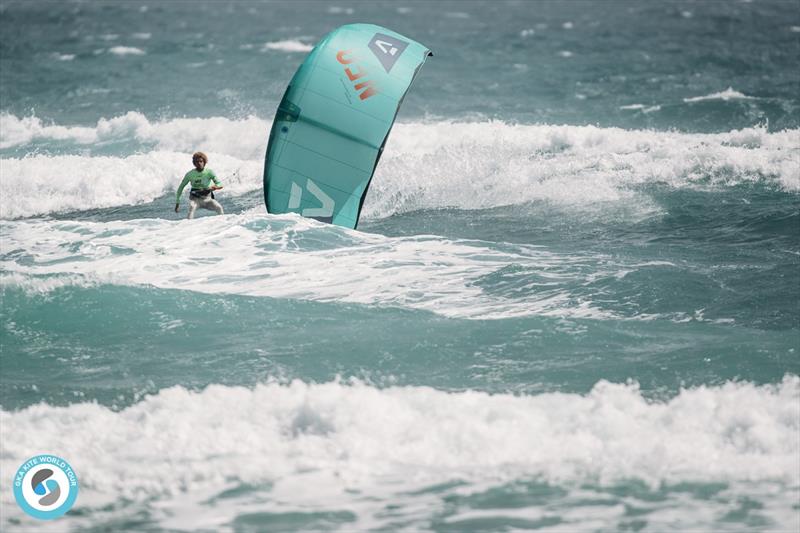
0, 214, 616, 319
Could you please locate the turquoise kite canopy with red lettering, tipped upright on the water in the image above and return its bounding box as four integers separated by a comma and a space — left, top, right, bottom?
264, 24, 433, 228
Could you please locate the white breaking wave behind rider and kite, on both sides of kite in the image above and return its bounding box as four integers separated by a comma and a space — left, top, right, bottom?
0, 114, 800, 218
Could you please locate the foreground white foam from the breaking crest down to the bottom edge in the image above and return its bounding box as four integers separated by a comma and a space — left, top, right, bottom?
0, 376, 800, 530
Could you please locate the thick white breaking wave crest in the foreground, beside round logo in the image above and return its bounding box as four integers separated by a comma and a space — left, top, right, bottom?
0, 376, 800, 497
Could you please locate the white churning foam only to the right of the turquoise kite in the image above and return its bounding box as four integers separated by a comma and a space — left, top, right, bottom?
363, 122, 800, 217
